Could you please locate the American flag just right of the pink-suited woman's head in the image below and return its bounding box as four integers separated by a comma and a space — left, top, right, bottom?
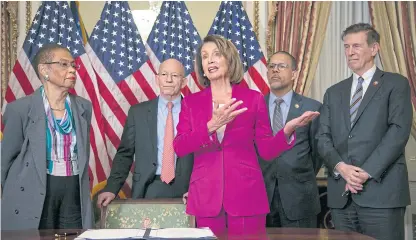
208, 1, 269, 94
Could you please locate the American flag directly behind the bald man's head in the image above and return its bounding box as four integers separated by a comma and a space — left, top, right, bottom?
146, 1, 202, 95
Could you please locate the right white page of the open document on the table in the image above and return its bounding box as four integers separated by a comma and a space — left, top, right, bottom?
150, 228, 215, 238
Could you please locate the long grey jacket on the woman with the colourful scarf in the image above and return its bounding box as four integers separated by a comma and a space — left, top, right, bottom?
1, 89, 94, 230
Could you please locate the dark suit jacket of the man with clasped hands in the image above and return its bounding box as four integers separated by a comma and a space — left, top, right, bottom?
317, 69, 413, 208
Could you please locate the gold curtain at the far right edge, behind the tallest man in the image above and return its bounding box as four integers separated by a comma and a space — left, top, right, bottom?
369, 1, 416, 137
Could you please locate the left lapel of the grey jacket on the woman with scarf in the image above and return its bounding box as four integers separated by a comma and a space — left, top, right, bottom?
28, 89, 46, 187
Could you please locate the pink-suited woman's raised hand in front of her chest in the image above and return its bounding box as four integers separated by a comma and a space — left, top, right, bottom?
207, 98, 247, 133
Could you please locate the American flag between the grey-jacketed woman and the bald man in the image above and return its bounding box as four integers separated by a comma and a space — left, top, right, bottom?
85, 1, 159, 197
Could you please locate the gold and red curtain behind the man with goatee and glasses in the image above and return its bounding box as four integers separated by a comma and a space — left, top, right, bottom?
267, 1, 331, 94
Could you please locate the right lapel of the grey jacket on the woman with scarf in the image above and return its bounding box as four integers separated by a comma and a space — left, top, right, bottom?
70, 95, 89, 178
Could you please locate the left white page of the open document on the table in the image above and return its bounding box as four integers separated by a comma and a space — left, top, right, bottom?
75, 229, 145, 240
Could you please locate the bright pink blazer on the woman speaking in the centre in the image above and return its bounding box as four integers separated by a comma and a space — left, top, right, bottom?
174, 85, 295, 217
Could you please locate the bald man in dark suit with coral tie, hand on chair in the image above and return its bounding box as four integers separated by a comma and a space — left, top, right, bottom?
98, 59, 193, 206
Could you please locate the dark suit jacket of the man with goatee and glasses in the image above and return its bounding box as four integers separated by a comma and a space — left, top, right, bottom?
259, 93, 322, 220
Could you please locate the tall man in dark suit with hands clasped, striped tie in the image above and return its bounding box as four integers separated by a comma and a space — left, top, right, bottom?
317, 23, 412, 240
